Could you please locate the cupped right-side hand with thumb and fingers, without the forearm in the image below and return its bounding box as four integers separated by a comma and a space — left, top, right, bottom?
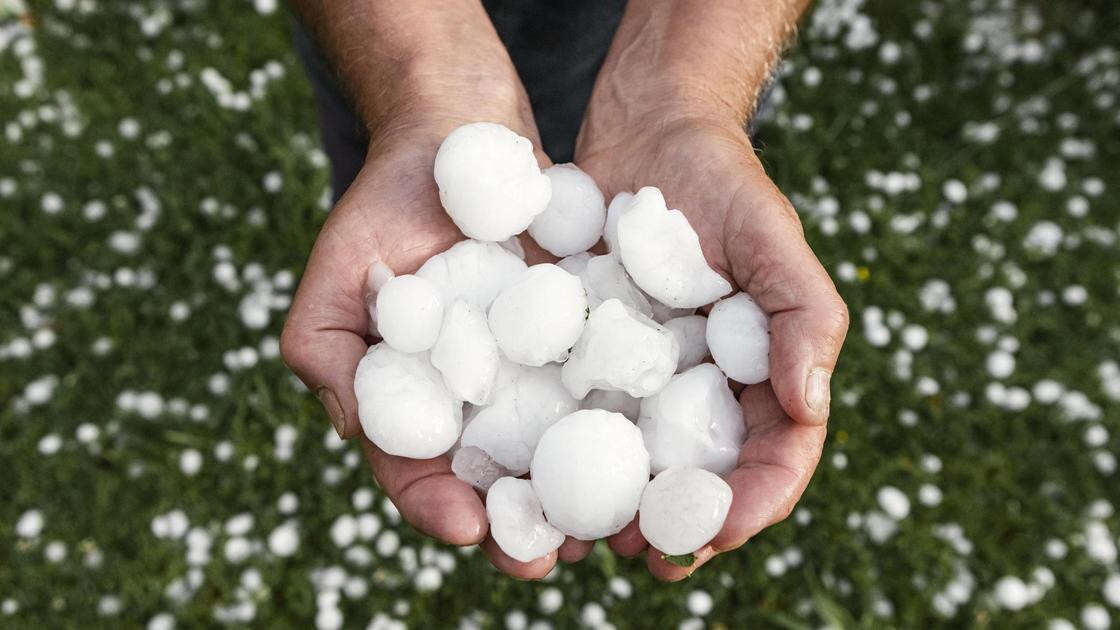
576, 107, 848, 580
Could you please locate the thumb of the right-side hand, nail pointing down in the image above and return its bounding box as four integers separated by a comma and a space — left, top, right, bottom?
726, 175, 848, 425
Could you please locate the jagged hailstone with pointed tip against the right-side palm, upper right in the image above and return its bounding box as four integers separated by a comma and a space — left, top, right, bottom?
617, 186, 731, 308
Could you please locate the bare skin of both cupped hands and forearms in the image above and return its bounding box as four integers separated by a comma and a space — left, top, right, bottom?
281, 0, 848, 580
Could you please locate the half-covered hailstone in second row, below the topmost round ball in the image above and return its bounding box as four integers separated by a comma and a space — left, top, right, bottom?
417, 241, 526, 313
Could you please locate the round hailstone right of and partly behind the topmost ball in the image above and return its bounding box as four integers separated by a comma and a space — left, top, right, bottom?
529, 164, 607, 257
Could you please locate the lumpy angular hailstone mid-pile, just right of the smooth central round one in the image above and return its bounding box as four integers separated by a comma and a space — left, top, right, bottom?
561, 299, 680, 398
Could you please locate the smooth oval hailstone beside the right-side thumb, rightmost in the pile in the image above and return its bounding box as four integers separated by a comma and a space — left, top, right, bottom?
707, 293, 769, 385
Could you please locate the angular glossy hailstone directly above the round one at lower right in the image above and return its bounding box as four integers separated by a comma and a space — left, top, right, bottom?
637, 363, 747, 474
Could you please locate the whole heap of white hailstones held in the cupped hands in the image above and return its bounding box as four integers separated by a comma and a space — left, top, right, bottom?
354, 122, 769, 562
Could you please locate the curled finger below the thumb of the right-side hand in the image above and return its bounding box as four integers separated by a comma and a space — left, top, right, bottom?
711, 383, 825, 552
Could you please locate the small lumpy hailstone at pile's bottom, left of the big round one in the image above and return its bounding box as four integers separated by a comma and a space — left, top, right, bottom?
486, 476, 563, 563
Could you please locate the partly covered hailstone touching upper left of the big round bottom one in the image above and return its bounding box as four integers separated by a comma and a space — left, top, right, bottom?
460, 361, 579, 476
